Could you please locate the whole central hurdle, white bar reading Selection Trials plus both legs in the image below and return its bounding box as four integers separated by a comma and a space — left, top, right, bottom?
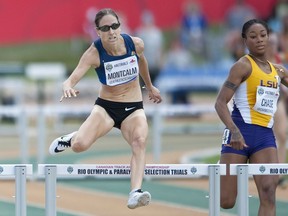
38, 164, 226, 216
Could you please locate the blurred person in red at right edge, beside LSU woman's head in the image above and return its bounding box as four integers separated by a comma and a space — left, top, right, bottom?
279, 14, 288, 65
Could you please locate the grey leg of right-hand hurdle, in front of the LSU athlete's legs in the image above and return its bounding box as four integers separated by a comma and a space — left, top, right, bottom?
237, 165, 249, 216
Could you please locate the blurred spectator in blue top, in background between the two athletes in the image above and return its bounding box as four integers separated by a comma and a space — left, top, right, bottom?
181, 0, 207, 56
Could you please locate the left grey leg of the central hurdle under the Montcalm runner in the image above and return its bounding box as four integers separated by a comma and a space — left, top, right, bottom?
45, 166, 57, 216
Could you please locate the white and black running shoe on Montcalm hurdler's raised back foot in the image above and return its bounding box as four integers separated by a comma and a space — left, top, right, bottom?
49, 131, 76, 155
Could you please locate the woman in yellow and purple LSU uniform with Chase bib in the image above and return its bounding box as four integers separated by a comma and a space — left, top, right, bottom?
215, 19, 288, 216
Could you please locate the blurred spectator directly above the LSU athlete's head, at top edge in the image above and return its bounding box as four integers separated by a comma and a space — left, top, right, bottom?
226, 0, 257, 30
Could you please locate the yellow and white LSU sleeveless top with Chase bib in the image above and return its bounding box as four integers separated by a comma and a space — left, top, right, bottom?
232, 55, 281, 128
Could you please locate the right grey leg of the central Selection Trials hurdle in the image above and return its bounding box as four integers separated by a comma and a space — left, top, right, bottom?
208, 165, 220, 216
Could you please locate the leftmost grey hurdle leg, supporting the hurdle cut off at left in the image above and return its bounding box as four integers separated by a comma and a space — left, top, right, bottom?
15, 166, 27, 216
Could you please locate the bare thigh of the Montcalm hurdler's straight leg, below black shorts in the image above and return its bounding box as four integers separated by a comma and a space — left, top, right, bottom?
121, 109, 148, 144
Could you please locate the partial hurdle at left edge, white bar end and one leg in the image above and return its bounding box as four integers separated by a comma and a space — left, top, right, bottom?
0, 164, 33, 216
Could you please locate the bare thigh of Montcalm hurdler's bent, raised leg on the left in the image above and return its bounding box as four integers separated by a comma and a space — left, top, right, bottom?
77, 105, 114, 141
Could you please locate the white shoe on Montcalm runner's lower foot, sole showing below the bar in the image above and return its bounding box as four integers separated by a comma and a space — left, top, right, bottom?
127, 189, 151, 209
